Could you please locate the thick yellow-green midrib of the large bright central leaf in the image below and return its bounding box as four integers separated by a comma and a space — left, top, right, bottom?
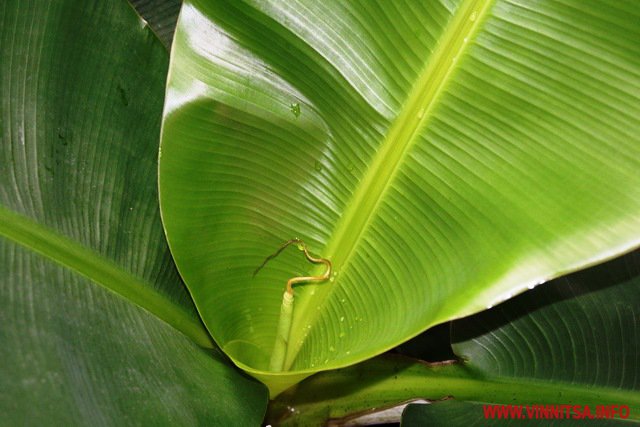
285, 0, 493, 369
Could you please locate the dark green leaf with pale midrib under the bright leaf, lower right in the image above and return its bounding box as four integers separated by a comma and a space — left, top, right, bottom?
267, 252, 640, 427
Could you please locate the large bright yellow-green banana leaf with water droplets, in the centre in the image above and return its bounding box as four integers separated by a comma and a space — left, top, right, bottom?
160, 0, 640, 394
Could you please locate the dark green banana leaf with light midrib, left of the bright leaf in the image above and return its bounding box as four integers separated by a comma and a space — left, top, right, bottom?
0, 0, 266, 426
